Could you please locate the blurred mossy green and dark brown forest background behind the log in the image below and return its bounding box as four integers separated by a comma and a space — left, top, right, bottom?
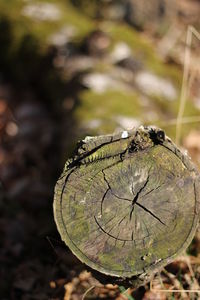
0, 0, 200, 299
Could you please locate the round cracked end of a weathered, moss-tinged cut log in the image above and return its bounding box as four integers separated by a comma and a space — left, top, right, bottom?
54, 126, 200, 286
